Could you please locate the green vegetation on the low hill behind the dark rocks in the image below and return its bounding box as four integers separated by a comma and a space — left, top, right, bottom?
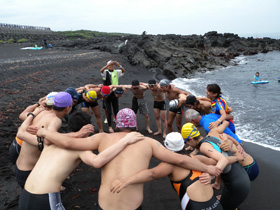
54, 30, 131, 39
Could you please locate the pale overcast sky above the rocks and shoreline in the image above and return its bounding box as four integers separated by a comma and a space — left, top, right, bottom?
0, 0, 280, 38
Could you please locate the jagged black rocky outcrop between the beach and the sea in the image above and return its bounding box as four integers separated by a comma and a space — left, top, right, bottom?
9, 31, 280, 79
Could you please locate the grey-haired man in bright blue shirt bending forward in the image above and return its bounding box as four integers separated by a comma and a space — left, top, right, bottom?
185, 109, 241, 144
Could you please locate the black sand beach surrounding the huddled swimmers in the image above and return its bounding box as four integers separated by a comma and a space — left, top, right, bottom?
0, 45, 280, 210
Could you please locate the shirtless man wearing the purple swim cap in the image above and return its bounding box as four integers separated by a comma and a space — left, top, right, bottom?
15, 92, 91, 188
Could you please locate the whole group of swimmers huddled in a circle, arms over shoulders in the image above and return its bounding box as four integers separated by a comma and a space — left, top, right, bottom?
10, 61, 259, 210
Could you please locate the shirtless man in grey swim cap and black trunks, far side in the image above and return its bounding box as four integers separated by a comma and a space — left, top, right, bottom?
159, 79, 189, 133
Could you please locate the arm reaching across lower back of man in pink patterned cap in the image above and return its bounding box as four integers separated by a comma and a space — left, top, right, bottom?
110, 163, 173, 193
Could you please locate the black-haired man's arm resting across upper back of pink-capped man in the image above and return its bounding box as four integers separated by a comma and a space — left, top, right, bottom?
80, 132, 144, 168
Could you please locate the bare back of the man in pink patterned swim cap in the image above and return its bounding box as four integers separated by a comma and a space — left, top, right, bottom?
98, 132, 153, 210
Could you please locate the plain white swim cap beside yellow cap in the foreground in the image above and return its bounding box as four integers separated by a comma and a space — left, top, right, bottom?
164, 132, 185, 152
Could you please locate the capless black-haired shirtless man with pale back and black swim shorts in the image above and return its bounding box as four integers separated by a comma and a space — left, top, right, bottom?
19, 111, 144, 210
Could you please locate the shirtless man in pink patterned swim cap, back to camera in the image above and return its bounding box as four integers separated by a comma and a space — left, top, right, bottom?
37, 108, 220, 210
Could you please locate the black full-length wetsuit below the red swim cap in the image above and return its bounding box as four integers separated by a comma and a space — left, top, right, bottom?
104, 92, 119, 127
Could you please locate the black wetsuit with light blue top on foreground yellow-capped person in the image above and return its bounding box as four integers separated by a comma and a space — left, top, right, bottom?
198, 137, 250, 210
